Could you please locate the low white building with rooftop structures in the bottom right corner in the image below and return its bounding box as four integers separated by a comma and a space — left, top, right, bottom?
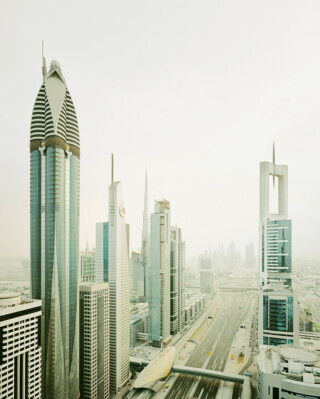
257, 346, 320, 399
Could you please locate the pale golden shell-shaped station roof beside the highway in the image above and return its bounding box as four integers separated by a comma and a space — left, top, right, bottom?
133, 347, 176, 388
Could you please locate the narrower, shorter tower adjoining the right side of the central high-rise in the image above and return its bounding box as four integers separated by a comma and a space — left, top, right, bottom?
170, 227, 185, 335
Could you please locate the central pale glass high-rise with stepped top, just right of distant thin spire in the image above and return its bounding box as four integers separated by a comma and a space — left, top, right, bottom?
148, 200, 170, 347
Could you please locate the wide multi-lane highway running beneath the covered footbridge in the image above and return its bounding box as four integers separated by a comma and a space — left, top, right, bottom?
165, 292, 255, 399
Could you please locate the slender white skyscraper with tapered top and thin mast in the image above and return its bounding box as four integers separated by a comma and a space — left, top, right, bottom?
108, 157, 130, 394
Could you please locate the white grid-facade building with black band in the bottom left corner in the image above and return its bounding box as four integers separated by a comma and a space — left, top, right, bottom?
0, 292, 41, 399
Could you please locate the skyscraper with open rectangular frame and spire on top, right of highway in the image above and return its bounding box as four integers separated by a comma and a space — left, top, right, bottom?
258, 147, 299, 345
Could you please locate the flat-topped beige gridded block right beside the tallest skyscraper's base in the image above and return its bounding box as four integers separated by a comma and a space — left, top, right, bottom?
79, 282, 109, 399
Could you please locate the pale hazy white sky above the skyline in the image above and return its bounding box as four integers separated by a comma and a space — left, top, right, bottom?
0, 0, 320, 257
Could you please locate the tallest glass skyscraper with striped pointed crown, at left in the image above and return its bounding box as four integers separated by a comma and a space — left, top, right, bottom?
30, 59, 80, 399
